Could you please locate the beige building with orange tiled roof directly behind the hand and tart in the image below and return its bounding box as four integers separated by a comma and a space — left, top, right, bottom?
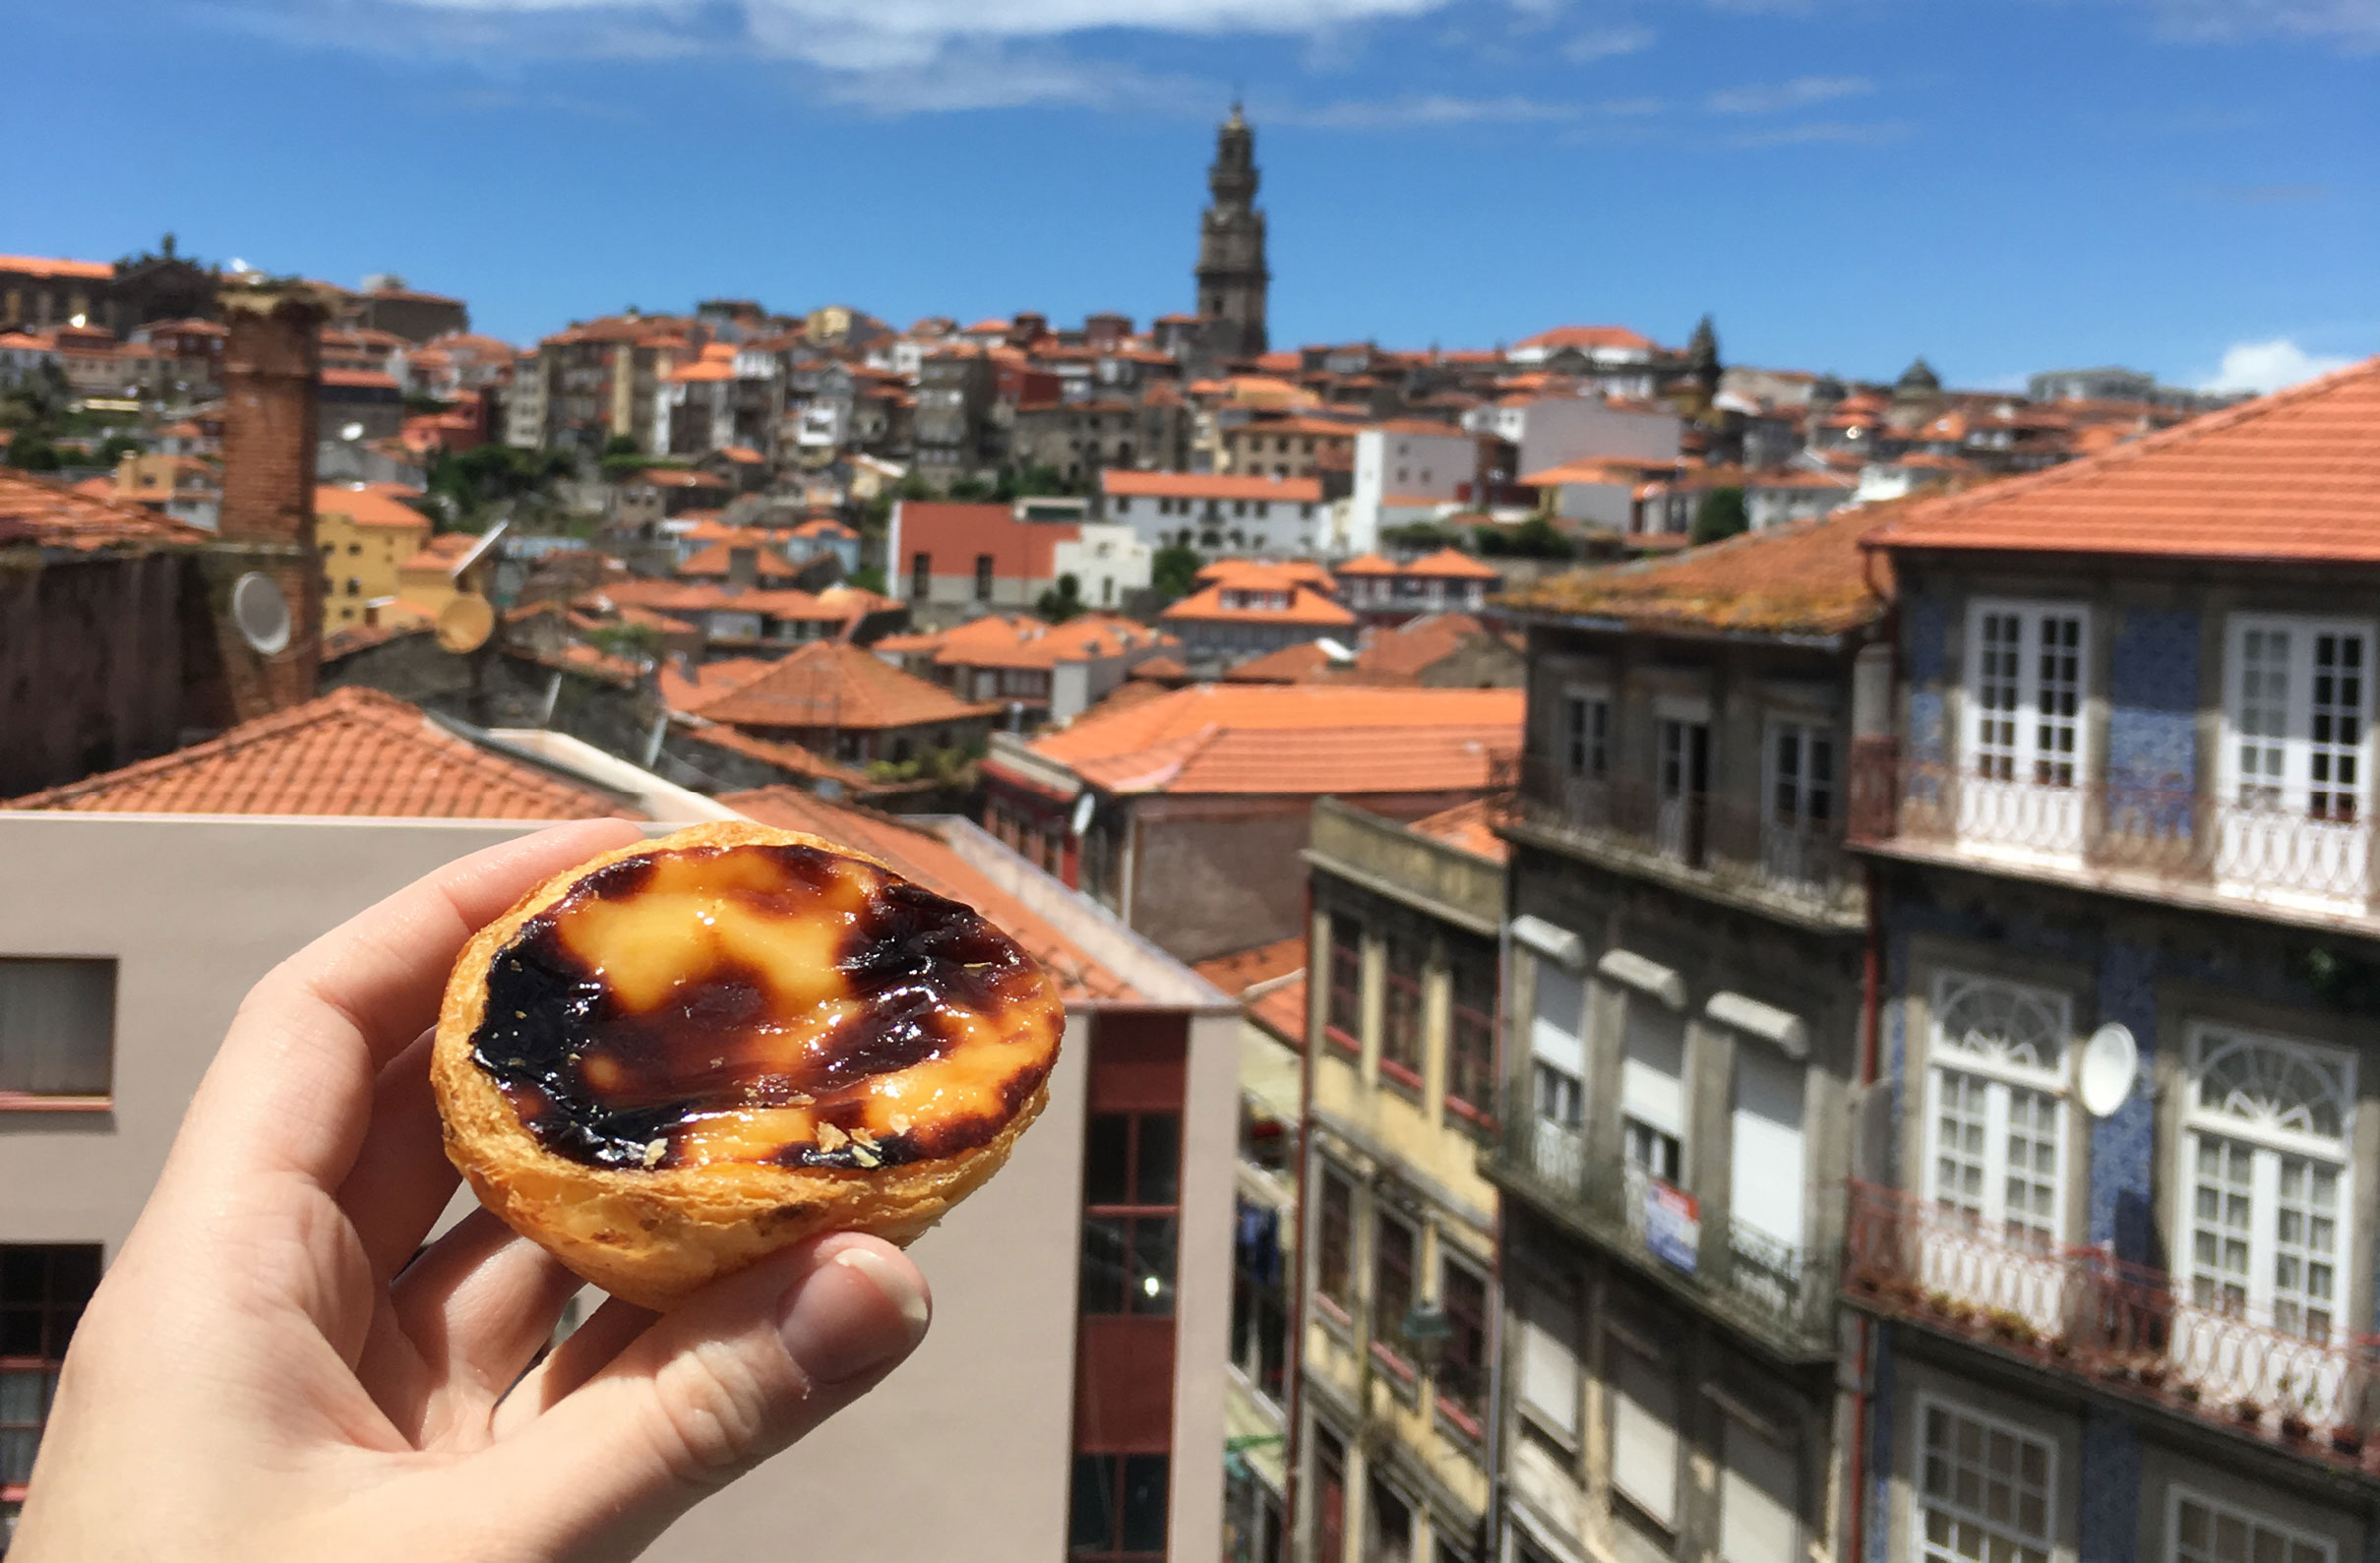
0, 690, 1238, 1563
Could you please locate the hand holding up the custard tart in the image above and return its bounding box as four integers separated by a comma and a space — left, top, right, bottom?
10, 820, 928, 1563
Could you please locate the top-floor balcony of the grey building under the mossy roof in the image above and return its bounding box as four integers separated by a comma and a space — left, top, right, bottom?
1495, 754, 1865, 928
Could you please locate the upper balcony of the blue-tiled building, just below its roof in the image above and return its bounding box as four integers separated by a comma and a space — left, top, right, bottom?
1850, 743, 2375, 928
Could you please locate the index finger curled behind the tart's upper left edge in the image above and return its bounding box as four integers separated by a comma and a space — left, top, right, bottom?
169, 820, 642, 1189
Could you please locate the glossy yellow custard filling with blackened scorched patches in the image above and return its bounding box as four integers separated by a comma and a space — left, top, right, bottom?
471, 845, 1059, 1169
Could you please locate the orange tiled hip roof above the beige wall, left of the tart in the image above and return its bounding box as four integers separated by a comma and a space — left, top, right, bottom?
5, 688, 641, 818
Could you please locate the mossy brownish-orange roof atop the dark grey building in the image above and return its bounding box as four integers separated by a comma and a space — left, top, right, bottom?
1504, 505, 1902, 635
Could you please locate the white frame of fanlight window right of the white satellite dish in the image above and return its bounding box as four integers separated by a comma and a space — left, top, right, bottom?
2173, 1021, 2356, 1342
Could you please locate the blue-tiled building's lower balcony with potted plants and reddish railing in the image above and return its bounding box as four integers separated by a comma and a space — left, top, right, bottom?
1845, 1182, 2380, 1477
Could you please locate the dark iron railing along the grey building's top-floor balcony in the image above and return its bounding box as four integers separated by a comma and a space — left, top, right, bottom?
1497, 754, 1852, 904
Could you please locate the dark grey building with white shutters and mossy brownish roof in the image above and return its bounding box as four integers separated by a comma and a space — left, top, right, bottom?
1485, 516, 1884, 1563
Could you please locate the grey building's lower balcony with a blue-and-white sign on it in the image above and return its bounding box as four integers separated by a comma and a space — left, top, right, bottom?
1481, 1109, 1837, 1360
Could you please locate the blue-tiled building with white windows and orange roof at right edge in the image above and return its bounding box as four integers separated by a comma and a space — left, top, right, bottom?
1847, 359, 2380, 1563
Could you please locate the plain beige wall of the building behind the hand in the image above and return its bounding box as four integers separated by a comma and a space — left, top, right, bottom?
0, 813, 1094, 1563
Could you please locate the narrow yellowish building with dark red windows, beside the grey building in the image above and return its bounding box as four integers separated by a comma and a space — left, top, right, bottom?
1297, 800, 1504, 1563
